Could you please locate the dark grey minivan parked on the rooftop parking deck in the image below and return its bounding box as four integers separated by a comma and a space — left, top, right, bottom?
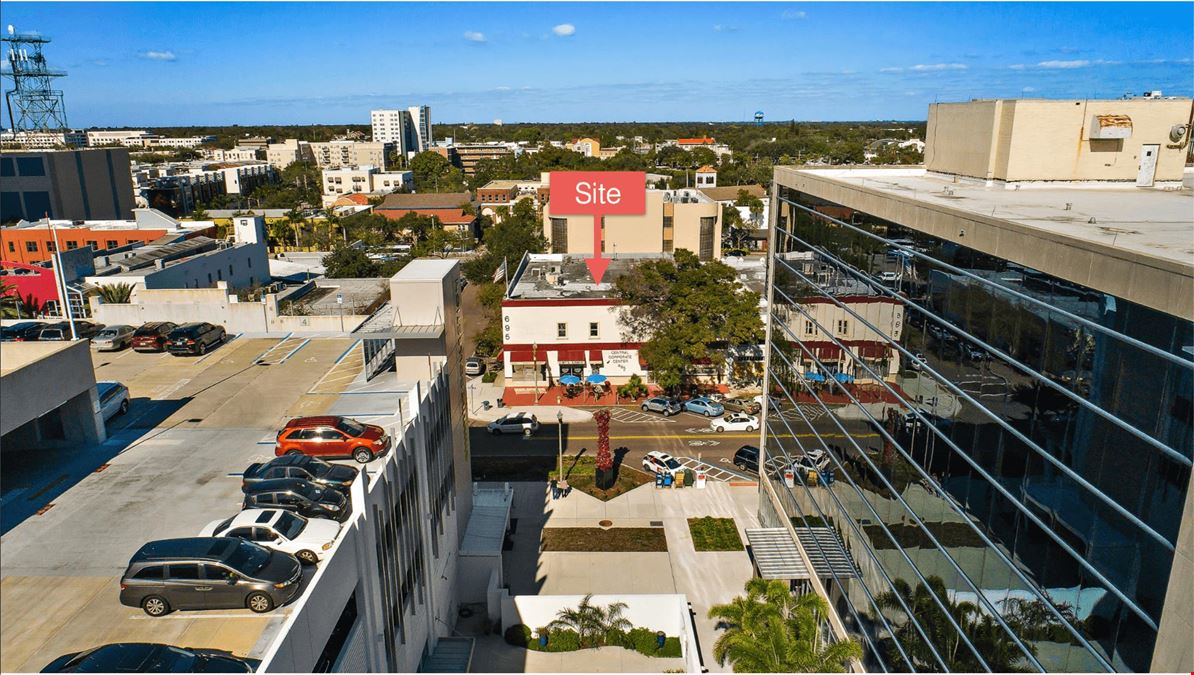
121, 536, 302, 616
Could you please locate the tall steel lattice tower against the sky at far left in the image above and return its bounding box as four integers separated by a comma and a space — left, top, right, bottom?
0, 24, 67, 133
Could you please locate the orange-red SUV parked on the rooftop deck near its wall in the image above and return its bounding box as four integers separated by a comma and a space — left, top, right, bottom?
273, 415, 389, 464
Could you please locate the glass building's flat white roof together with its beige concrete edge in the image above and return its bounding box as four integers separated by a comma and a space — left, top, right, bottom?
775, 166, 1194, 319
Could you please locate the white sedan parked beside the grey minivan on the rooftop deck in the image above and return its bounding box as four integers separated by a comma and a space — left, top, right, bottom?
199, 509, 340, 565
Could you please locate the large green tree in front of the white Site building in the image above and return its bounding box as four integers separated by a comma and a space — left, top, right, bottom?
614, 248, 763, 389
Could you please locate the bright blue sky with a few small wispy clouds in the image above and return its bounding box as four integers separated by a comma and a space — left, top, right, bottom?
4, 0, 1194, 127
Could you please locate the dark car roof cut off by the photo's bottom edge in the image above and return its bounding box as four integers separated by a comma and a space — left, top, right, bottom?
42, 643, 253, 673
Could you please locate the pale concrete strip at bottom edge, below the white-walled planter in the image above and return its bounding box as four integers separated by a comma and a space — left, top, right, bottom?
473, 636, 684, 673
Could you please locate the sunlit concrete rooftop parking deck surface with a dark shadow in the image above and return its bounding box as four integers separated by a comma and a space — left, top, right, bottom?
0, 337, 361, 671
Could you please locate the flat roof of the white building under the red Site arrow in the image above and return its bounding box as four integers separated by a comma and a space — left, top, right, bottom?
506, 253, 670, 300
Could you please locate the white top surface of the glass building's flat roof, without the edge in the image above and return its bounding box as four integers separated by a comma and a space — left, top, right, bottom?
798, 168, 1194, 269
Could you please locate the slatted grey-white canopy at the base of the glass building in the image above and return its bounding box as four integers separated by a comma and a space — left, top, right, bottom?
746, 527, 858, 579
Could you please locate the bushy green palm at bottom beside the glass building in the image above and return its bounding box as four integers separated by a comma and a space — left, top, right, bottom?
709, 578, 862, 673
